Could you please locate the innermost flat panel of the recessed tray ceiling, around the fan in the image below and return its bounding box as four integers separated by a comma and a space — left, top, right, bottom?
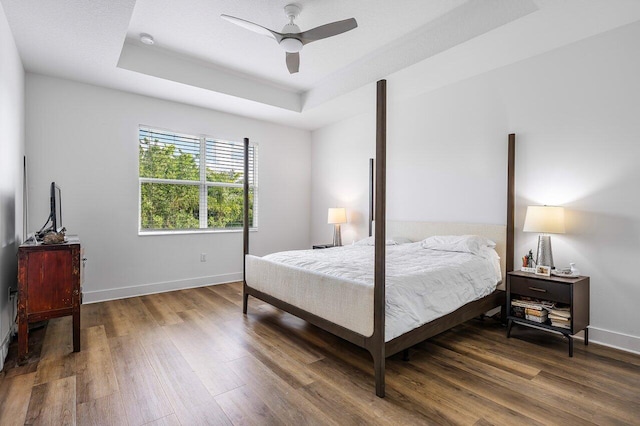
127, 0, 472, 91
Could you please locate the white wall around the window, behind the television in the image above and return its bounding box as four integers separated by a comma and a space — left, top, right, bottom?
26, 73, 311, 302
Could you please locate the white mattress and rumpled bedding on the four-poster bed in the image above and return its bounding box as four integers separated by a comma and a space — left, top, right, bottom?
245, 243, 501, 341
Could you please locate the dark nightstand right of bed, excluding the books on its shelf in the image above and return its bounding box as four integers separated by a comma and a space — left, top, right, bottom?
507, 271, 589, 357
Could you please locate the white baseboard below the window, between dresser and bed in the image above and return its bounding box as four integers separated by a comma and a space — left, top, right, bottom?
82, 272, 242, 303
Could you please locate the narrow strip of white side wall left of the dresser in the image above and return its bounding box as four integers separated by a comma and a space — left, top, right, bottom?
0, 5, 24, 370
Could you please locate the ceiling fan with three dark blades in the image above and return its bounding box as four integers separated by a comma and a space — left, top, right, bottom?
220, 4, 358, 74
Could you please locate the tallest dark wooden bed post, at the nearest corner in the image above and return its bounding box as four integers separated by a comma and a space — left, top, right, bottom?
370, 80, 387, 398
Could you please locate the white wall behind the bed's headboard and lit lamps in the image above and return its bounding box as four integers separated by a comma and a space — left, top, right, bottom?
311, 23, 640, 352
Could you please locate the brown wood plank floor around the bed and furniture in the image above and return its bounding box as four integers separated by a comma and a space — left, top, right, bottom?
0, 284, 640, 425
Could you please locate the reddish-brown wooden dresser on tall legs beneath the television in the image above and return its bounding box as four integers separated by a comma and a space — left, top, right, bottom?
18, 236, 82, 363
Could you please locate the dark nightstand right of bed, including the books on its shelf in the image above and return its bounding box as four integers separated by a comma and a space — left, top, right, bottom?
507, 271, 589, 357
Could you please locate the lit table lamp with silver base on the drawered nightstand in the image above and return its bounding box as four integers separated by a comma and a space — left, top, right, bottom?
522, 206, 565, 269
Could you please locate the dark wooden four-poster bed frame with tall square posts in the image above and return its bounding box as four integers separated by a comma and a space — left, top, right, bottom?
242, 80, 515, 398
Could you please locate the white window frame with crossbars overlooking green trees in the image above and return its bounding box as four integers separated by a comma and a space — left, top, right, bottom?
138, 125, 259, 236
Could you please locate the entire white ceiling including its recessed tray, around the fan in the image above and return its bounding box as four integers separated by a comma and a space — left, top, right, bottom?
0, 0, 640, 129
